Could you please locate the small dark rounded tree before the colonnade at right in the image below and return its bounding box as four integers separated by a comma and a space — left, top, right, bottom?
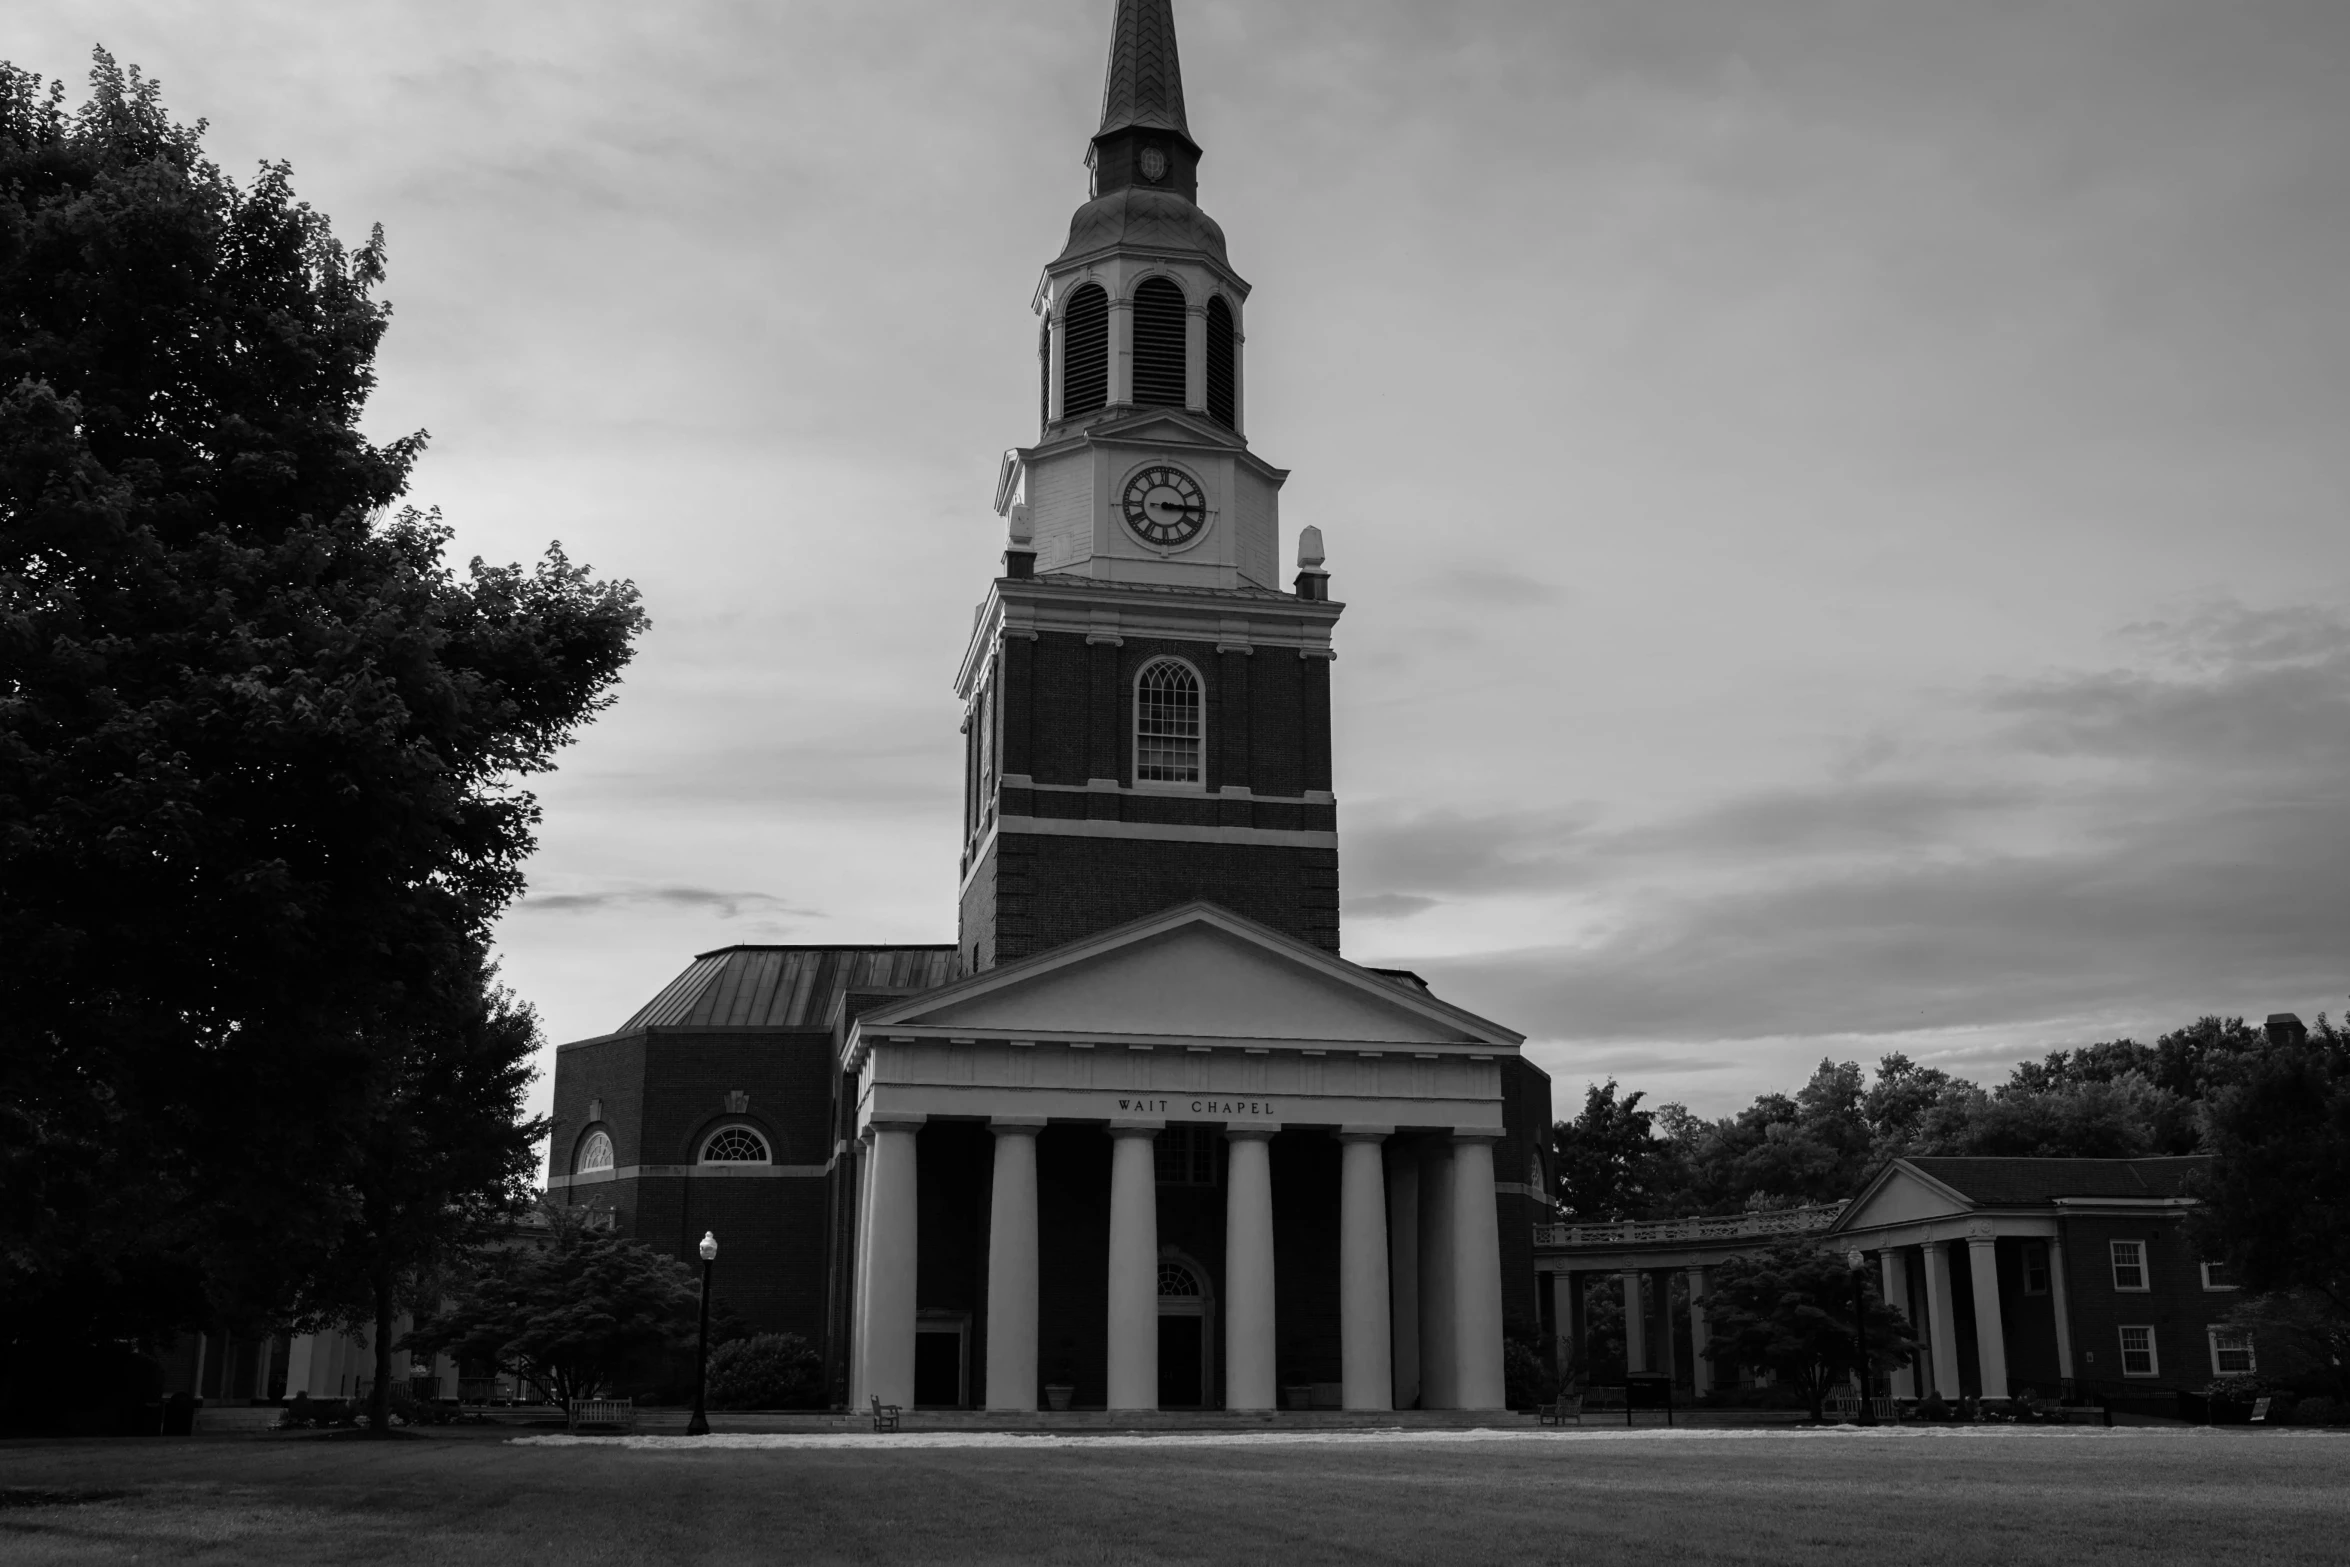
1706, 1240, 1918, 1419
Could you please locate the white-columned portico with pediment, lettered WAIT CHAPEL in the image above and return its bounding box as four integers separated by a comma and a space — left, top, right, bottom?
844, 904, 1520, 1412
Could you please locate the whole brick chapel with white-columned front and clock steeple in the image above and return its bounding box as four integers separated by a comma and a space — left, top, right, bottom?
548, 0, 1551, 1412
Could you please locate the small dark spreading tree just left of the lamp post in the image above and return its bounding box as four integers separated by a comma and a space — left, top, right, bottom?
400, 1203, 700, 1403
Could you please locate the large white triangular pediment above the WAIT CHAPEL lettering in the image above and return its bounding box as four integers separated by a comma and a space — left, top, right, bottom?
858, 904, 1518, 1050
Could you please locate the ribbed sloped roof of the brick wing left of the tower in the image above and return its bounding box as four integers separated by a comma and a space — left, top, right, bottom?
616, 944, 956, 1034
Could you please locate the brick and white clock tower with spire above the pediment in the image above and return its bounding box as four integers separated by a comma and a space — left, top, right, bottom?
956, 0, 1340, 970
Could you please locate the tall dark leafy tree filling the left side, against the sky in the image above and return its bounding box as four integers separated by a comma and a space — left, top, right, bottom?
0, 52, 644, 1337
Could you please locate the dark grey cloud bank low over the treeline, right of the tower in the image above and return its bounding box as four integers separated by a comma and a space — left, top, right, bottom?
1358, 604, 2350, 1052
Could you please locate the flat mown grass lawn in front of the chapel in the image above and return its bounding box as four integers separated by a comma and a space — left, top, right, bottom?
0, 1428, 2350, 1567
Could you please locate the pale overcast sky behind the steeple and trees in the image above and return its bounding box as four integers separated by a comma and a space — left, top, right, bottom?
22, 0, 2350, 1114
